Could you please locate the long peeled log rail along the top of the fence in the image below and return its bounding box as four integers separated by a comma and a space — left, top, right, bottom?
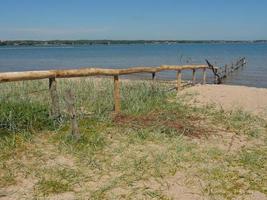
0, 65, 208, 83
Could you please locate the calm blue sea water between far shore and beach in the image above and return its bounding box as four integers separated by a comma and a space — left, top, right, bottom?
0, 44, 267, 88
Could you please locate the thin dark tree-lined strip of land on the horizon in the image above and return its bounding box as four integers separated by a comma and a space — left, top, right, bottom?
0, 40, 267, 46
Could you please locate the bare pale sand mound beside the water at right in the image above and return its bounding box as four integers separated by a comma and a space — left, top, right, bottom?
182, 85, 267, 118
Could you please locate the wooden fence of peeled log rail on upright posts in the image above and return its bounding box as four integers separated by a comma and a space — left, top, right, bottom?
0, 65, 210, 114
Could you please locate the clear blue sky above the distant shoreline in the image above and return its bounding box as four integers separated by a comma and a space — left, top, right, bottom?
0, 0, 267, 40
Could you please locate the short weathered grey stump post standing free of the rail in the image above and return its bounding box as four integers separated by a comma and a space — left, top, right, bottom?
65, 89, 81, 140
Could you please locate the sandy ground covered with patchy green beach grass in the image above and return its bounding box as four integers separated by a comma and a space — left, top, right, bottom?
0, 78, 267, 199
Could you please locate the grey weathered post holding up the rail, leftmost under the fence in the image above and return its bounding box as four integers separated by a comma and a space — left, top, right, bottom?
49, 78, 61, 121
